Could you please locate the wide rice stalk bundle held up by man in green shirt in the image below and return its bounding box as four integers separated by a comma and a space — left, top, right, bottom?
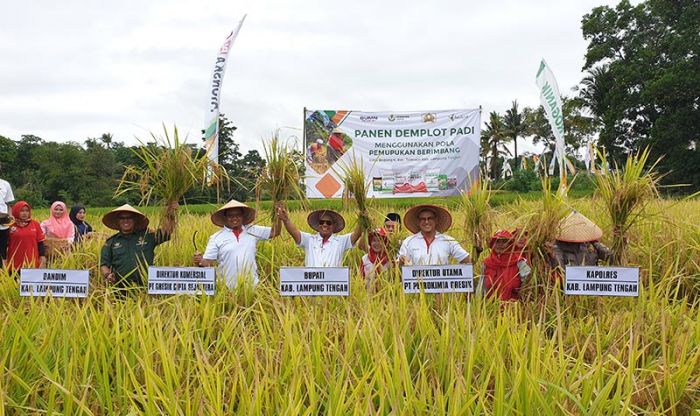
115, 125, 222, 221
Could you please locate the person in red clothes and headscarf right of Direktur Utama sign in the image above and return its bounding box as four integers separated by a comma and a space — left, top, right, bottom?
477, 230, 531, 300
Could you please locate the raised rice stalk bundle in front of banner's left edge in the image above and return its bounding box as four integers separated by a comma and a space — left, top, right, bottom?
255, 135, 306, 223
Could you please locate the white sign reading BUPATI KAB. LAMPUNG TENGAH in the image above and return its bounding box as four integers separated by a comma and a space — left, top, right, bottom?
280, 267, 350, 296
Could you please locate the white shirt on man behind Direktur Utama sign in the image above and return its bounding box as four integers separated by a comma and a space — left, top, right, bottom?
399, 233, 469, 266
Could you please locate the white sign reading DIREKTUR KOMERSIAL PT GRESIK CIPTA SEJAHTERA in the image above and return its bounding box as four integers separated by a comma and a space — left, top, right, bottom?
148, 267, 216, 296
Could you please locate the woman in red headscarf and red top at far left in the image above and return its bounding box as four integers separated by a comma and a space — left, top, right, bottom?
7, 201, 46, 273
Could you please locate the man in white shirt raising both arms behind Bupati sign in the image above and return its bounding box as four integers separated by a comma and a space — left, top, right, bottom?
277, 207, 367, 267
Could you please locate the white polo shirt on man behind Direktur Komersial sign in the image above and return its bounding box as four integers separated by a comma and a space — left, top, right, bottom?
202, 225, 272, 289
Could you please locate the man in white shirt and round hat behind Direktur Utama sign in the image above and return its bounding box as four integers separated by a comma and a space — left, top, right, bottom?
398, 204, 470, 266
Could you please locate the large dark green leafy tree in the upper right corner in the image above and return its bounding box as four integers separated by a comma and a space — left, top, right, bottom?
579, 0, 700, 188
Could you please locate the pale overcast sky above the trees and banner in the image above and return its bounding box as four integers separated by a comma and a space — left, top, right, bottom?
0, 0, 616, 154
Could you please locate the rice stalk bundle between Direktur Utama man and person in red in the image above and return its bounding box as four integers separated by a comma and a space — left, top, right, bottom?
461, 177, 495, 262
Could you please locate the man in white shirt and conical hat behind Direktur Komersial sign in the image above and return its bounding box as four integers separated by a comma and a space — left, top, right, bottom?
193, 200, 281, 289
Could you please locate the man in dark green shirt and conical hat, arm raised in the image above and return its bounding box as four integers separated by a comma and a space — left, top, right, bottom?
100, 202, 178, 288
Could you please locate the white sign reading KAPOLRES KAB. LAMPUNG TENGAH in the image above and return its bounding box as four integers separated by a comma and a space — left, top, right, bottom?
564, 266, 639, 296
